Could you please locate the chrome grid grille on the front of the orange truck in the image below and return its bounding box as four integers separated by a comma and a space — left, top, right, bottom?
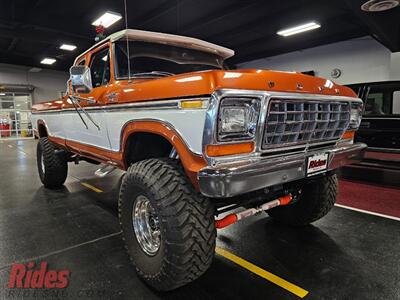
262, 98, 350, 150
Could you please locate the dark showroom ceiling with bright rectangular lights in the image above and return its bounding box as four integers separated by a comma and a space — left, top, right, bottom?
0, 0, 400, 70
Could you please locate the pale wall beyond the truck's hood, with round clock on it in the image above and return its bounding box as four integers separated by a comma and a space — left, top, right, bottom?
239, 37, 400, 84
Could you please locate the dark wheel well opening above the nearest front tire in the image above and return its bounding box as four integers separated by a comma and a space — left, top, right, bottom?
124, 132, 173, 167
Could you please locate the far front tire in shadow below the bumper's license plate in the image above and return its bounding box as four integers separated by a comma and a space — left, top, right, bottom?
268, 174, 338, 226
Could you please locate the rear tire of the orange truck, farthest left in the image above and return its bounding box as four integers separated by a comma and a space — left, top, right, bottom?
36, 137, 68, 189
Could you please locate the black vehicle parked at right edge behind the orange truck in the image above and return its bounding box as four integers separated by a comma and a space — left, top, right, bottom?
342, 81, 400, 187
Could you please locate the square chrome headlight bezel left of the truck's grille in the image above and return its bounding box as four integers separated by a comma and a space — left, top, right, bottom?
215, 96, 261, 143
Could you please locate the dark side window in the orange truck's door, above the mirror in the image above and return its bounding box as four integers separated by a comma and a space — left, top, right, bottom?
90, 48, 110, 88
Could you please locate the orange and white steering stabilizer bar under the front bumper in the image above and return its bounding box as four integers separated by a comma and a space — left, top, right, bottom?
215, 194, 293, 229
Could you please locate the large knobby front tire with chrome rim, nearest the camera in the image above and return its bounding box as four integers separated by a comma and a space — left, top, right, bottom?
118, 159, 216, 291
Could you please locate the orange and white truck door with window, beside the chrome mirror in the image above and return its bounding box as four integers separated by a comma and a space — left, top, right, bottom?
64, 44, 110, 149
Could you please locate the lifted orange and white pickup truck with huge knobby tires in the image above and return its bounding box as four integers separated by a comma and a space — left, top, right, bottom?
32, 30, 366, 290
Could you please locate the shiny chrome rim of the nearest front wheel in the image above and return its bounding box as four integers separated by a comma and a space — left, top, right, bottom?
132, 195, 161, 256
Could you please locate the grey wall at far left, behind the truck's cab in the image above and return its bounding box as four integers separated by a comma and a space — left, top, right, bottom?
0, 64, 68, 103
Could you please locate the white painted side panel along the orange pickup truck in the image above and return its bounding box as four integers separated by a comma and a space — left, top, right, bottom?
32, 108, 206, 154
